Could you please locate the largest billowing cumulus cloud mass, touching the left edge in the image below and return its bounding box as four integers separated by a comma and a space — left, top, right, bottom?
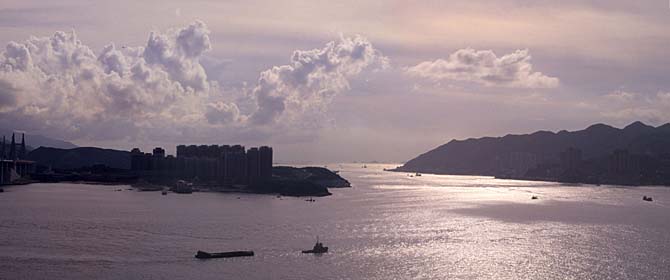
0, 22, 211, 141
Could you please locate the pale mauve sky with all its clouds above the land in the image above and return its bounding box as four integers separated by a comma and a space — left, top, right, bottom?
0, 0, 670, 163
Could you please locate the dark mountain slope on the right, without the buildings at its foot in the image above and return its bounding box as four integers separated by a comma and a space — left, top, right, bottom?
396, 122, 670, 183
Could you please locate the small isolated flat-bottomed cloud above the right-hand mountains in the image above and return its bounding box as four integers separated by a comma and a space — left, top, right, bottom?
406, 48, 559, 88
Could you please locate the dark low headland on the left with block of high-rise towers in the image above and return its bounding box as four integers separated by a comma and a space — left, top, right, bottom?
0, 141, 351, 196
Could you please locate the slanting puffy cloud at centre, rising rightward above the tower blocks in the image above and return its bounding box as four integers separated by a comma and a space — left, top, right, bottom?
251, 36, 388, 124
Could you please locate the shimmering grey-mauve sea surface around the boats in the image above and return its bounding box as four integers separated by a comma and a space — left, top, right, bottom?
0, 164, 670, 279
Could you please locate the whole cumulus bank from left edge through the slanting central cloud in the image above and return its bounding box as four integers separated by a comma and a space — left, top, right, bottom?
0, 21, 388, 147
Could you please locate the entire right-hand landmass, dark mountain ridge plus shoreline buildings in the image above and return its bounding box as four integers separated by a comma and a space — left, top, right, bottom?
393, 122, 670, 185
